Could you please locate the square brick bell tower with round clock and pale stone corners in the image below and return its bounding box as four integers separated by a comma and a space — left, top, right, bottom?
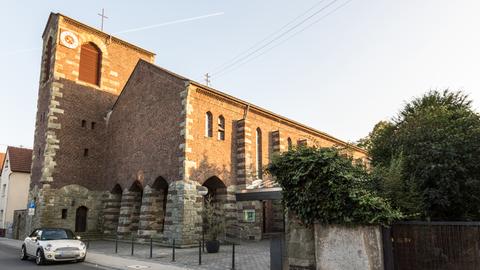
27, 13, 155, 232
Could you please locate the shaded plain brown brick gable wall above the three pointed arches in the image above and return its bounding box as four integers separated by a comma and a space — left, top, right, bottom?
104, 62, 185, 190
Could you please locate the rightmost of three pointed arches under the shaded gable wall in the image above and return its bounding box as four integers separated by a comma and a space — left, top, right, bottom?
139, 176, 168, 237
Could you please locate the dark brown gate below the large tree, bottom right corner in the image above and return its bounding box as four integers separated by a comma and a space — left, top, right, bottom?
384, 222, 480, 270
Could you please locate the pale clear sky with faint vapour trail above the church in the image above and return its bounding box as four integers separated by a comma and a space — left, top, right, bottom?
0, 0, 480, 150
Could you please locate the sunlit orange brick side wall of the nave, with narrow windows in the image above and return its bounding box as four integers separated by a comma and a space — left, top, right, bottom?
187, 85, 366, 186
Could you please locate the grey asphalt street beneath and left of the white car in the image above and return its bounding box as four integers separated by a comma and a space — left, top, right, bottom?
0, 245, 110, 270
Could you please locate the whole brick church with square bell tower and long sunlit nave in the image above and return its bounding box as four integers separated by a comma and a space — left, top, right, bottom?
27, 13, 366, 244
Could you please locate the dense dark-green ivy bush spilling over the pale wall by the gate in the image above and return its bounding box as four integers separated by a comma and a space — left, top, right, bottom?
267, 147, 401, 224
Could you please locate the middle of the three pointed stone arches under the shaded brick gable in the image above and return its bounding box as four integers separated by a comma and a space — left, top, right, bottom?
117, 181, 143, 237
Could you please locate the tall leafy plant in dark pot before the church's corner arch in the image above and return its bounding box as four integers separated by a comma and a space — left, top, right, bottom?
203, 198, 225, 253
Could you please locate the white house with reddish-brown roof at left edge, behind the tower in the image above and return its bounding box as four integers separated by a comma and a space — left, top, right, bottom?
0, 146, 32, 235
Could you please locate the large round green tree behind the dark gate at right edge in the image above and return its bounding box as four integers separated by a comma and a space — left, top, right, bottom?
364, 90, 480, 220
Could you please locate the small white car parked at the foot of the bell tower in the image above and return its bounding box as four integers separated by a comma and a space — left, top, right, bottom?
20, 228, 87, 265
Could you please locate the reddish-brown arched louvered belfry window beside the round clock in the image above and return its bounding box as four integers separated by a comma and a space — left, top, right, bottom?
78, 43, 102, 85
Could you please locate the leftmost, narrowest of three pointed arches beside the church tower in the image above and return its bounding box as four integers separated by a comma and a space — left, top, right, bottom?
103, 184, 123, 235
